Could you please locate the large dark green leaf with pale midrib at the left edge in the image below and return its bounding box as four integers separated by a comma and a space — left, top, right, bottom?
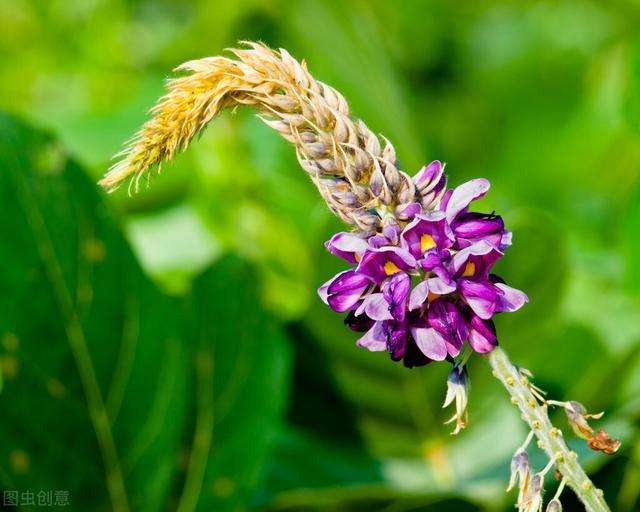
0, 112, 186, 510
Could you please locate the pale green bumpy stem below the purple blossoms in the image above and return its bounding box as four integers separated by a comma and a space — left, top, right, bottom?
489, 347, 610, 512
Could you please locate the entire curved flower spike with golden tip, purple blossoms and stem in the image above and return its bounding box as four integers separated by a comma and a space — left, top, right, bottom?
100, 42, 619, 512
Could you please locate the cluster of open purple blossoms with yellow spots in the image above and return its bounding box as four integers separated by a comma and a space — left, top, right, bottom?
318, 161, 528, 367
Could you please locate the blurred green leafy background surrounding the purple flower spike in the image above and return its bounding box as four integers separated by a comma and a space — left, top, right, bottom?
0, 0, 640, 512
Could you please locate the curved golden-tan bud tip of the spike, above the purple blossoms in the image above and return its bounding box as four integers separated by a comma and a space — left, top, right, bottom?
100, 42, 415, 231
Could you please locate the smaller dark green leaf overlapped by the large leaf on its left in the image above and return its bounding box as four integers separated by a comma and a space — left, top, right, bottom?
179, 257, 290, 511
